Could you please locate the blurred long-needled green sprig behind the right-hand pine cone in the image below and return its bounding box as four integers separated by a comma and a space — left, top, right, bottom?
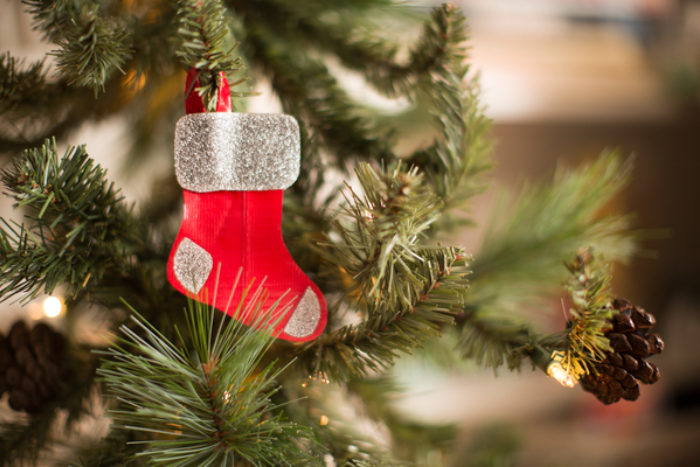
457, 153, 634, 369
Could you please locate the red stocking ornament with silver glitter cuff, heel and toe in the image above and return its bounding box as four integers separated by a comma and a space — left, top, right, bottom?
168, 70, 326, 341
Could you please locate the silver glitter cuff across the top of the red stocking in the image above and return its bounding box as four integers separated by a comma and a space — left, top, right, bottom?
175, 112, 301, 193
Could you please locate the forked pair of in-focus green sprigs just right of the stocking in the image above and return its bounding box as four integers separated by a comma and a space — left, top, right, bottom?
296, 160, 476, 380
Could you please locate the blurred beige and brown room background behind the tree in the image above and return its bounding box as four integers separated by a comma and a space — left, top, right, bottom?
0, 0, 700, 466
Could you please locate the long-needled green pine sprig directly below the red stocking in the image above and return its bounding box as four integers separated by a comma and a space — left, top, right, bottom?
98, 298, 312, 465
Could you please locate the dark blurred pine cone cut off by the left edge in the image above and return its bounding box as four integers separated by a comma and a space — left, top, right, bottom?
0, 321, 65, 414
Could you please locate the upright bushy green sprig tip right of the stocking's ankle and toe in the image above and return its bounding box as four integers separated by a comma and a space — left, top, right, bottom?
329, 164, 439, 308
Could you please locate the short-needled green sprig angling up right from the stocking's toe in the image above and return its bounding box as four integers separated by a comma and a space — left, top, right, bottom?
302, 248, 468, 381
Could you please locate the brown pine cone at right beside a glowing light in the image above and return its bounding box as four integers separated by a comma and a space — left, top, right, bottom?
581, 299, 664, 404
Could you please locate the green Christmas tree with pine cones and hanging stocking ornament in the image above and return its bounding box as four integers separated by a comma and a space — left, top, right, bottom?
0, 0, 663, 466
